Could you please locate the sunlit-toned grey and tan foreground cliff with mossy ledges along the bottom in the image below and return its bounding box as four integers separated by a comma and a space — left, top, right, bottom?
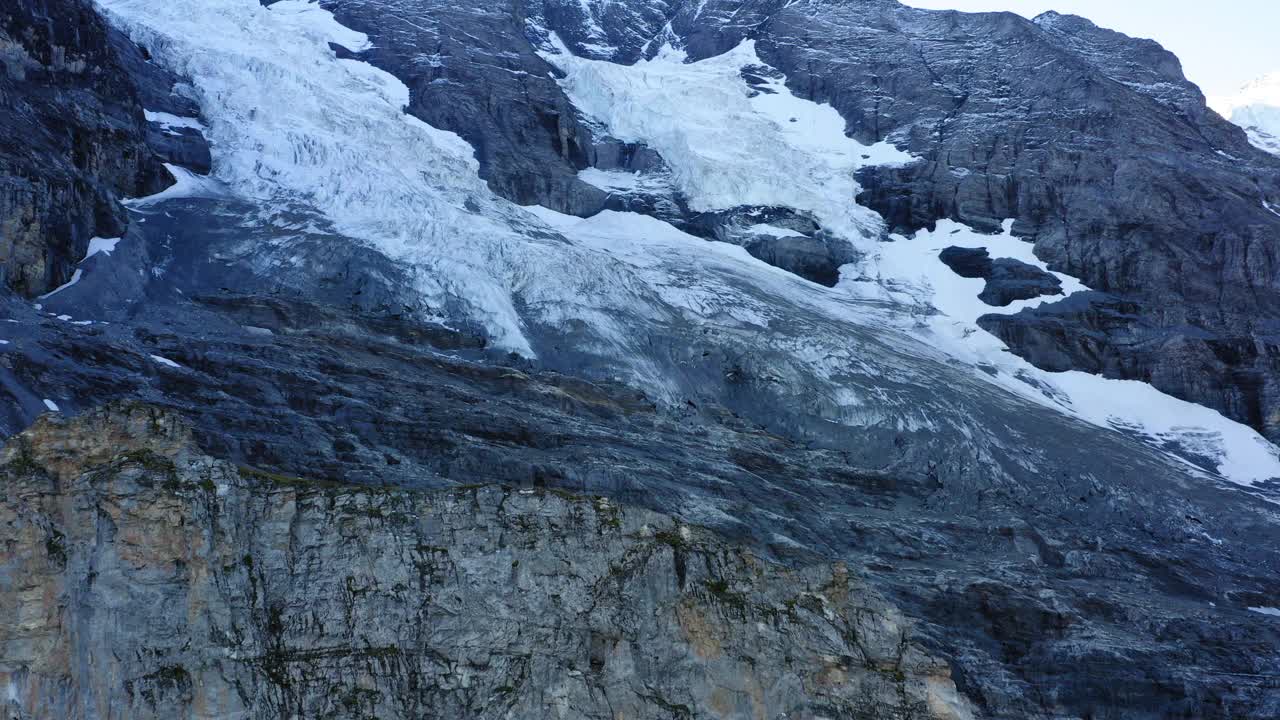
0, 405, 973, 720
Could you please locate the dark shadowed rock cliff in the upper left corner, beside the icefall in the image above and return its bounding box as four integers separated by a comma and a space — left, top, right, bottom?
0, 0, 173, 296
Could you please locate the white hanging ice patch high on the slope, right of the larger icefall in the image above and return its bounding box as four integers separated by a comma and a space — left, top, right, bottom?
543, 35, 915, 240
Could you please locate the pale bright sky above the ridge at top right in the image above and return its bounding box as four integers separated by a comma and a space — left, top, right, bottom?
901, 0, 1280, 97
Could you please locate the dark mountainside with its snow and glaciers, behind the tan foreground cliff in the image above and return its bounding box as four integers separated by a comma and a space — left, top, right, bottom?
0, 0, 1280, 717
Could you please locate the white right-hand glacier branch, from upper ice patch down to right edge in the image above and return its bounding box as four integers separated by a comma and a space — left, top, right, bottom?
544, 35, 1280, 484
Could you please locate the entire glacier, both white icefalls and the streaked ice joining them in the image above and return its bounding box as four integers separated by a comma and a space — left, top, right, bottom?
96, 0, 1280, 484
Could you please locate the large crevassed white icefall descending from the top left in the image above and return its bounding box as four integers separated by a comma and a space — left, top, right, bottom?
99, 0, 655, 356
